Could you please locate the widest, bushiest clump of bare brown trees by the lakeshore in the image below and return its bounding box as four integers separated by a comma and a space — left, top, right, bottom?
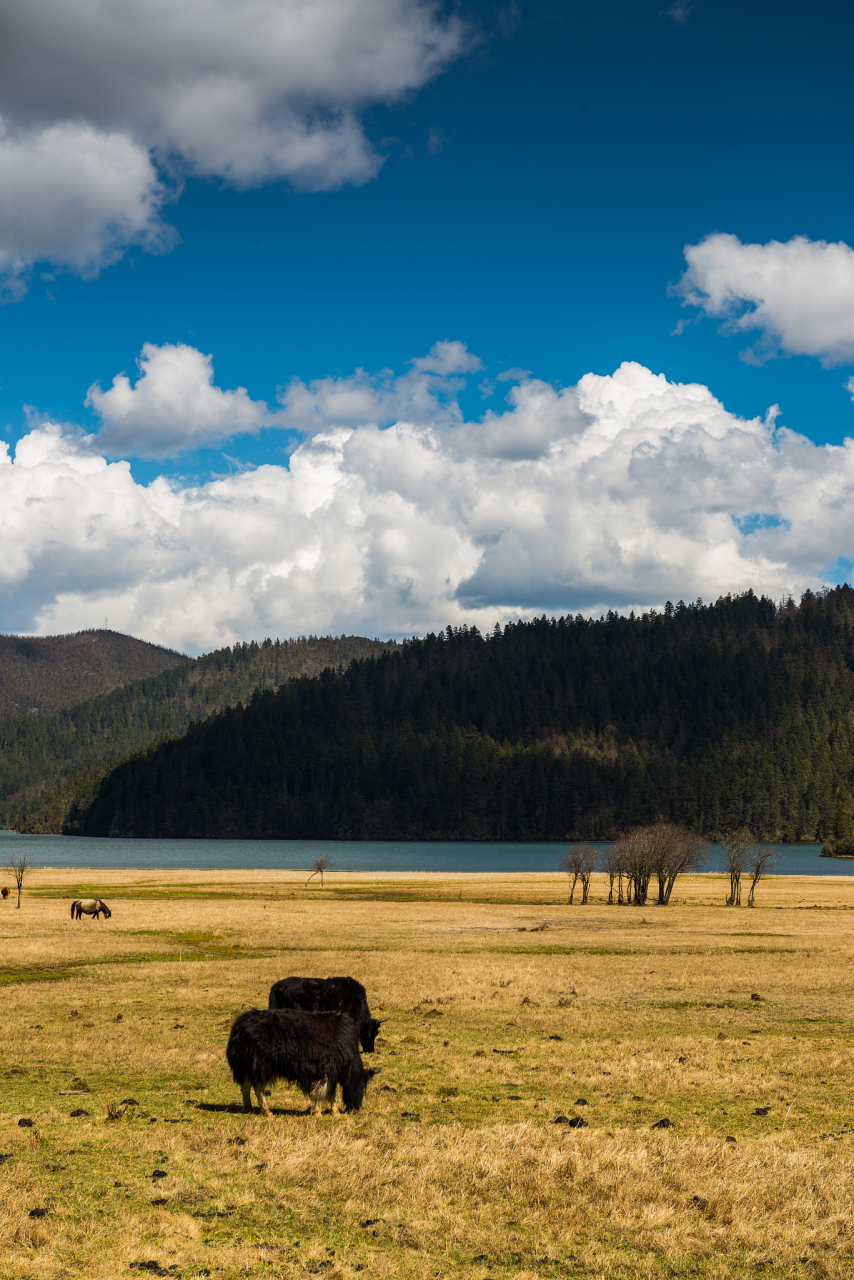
606, 822, 708, 906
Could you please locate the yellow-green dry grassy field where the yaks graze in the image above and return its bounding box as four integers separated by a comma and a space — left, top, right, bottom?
0, 870, 854, 1280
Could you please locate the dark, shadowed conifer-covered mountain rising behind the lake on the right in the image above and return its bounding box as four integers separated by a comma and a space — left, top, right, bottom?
67, 586, 854, 840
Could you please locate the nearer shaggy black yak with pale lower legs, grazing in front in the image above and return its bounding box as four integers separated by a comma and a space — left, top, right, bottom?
225, 1009, 376, 1119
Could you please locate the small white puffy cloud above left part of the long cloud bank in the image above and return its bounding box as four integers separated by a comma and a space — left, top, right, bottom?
86, 342, 275, 458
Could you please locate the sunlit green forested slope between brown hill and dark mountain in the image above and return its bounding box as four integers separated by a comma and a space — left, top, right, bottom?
0, 636, 396, 831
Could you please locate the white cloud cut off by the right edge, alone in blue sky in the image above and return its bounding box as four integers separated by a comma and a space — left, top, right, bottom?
672, 234, 854, 365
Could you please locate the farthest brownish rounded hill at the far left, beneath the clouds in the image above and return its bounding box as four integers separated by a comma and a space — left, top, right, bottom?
0, 631, 187, 716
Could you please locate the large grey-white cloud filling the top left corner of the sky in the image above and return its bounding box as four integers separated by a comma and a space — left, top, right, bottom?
0, 0, 469, 296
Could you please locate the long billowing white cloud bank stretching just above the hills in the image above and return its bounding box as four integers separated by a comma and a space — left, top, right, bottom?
0, 355, 854, 650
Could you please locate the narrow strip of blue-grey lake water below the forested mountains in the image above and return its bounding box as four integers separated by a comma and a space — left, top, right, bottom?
0, 831, 854, 876
